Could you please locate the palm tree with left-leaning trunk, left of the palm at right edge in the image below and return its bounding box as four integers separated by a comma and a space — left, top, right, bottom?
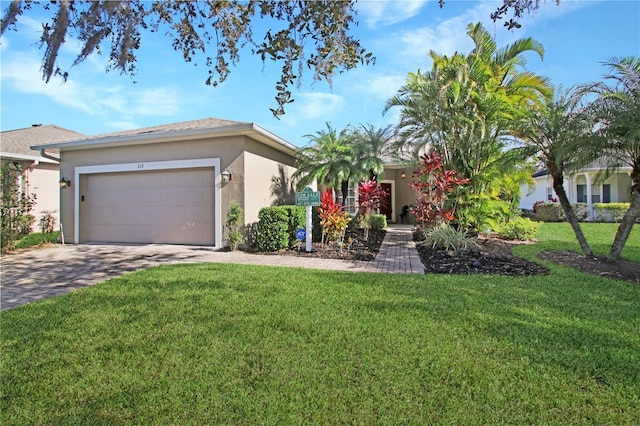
516, 88, 593, 256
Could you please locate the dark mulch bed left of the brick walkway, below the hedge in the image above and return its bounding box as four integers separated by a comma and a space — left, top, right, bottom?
265, 230, 386, 261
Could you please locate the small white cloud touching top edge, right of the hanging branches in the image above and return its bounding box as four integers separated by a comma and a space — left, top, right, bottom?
356, 0, 430, 28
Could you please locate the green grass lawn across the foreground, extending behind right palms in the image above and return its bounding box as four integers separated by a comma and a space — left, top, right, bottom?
0, 224, 640, 425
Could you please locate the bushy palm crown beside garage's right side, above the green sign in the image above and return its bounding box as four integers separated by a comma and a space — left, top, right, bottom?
292, 123, 353, 200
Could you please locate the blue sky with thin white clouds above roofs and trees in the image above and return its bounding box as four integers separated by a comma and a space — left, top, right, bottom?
0, 0, 640, 146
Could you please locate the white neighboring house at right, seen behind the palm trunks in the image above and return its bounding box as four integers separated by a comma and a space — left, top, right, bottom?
520, 162, 631, 220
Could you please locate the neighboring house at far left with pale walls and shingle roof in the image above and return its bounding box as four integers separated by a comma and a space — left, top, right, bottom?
0, 124, 85, 226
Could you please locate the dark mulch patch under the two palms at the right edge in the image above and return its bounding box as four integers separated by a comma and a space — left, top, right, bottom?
538, 251, 640, 283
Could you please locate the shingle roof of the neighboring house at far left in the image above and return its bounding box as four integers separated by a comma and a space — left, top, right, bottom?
0, 124, 86, 156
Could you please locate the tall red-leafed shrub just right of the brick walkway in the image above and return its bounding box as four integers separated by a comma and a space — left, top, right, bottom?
409, 152, 469, 229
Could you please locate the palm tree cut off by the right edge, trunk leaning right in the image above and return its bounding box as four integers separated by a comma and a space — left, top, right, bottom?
587, 57, 640, 261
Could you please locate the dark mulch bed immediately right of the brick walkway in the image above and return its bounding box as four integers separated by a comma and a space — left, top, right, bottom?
417, 239, 549, 276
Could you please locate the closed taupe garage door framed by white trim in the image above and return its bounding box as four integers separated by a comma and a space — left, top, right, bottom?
83, 168, 215, 245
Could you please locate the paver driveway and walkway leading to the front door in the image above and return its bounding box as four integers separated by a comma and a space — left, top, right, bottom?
0, 225, 424, 310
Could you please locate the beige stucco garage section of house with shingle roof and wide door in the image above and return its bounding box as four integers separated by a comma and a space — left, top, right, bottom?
32, 118, 297, 247
